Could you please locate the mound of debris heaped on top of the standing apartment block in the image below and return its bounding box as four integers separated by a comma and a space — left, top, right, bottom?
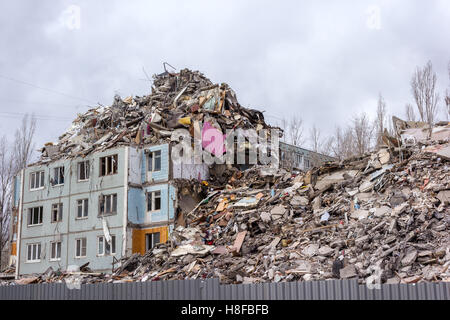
40, 69, 269, 163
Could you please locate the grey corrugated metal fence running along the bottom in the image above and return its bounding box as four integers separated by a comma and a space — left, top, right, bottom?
0, 279, 450, 300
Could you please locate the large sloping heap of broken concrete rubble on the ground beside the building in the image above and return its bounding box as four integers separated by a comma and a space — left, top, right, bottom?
104, 142, 450, 283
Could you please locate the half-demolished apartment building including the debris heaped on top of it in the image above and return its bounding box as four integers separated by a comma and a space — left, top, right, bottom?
12, 69, 278, 275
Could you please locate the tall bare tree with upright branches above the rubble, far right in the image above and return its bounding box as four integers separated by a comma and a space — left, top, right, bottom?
411, 61, 439, 128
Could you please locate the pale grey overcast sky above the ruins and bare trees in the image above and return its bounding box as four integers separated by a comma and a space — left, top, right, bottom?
0, 0, 450, 155
